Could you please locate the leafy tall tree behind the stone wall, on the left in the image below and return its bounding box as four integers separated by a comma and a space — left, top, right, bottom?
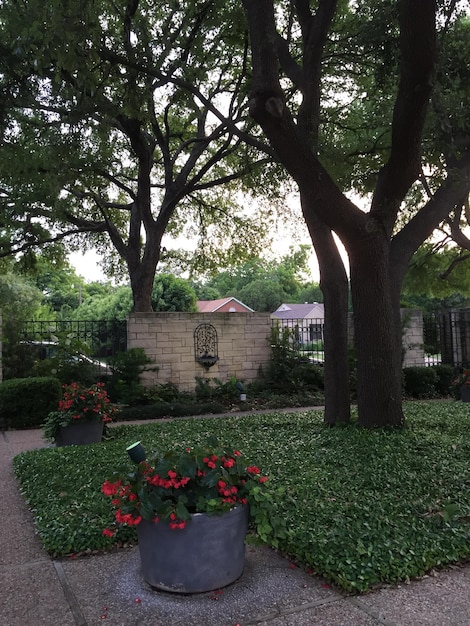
0, 0, 280, 311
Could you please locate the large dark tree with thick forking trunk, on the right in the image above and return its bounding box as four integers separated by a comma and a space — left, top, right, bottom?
243, 0, 470, 427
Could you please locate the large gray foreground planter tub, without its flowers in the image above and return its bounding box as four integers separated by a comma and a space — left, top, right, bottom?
137, 506, 248, 593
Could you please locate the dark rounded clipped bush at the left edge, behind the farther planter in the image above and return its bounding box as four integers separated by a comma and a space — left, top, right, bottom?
0, 376, 62, 429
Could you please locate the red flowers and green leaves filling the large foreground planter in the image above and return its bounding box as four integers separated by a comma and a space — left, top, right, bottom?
102, 439, 268, 536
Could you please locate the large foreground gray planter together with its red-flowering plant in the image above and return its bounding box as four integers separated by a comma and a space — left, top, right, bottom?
102, 439, 283, 593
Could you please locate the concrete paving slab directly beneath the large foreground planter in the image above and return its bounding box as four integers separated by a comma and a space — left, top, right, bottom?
61, 546, 339, 626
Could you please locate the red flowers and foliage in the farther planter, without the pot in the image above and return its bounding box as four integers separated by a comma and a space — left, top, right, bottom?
44, 383, 115, 441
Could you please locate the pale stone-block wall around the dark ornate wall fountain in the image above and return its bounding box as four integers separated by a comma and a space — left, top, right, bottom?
127, 313, 271, 391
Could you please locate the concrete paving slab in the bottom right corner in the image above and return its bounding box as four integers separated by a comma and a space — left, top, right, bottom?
357, 565, 470, 626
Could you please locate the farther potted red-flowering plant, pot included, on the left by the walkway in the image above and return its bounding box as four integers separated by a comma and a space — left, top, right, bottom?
44, 383, 114, 446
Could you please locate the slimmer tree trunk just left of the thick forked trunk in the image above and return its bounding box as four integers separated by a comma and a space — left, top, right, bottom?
300, 200, 351, 424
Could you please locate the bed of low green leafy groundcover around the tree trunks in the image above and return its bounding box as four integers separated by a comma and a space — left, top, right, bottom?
14, 401, 470, 591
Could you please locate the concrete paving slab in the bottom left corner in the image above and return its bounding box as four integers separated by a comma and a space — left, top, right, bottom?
0, 561, 75, 626
